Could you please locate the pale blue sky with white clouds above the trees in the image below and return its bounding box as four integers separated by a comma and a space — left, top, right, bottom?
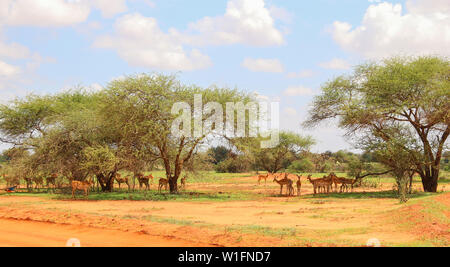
0, 0, 450, 152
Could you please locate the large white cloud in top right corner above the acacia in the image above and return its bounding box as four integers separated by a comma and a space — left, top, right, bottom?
333, 0, 450, 58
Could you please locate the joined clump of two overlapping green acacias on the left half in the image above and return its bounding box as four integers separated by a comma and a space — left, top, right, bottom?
0, 74, 250, 192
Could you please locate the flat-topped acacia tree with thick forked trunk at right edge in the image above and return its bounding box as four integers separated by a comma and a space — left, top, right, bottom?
305, 57, 450, 192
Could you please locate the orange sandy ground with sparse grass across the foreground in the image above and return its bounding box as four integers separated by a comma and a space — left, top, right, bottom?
0, 178, 450, 247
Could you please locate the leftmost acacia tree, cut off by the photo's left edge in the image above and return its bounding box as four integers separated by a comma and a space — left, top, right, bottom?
0, 90, 123, 191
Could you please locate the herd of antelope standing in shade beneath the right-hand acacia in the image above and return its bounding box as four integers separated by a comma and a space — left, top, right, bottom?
258, 173, 356, 196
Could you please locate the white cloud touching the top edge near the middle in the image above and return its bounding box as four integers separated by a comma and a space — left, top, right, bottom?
177, 0, 284, 46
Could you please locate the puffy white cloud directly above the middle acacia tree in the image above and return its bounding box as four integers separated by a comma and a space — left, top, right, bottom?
94, 13, 212, 71
